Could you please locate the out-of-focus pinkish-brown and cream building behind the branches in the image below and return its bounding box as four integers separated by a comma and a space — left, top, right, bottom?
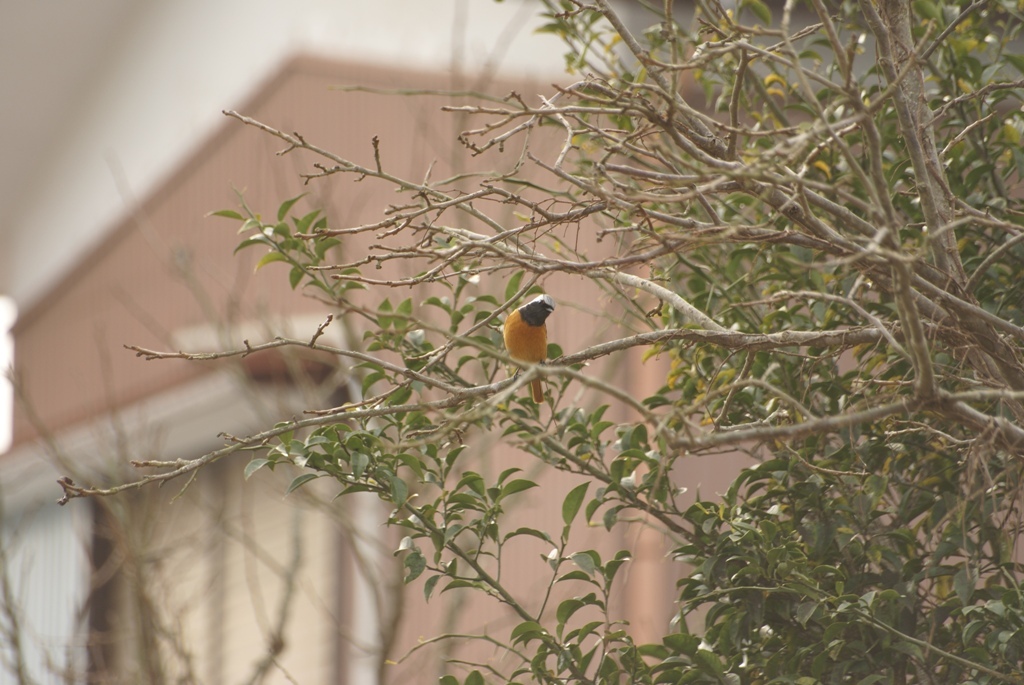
0, 0, 753, 684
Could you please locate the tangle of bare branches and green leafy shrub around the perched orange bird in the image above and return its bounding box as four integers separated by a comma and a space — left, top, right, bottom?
65, 0, 1024, 685
